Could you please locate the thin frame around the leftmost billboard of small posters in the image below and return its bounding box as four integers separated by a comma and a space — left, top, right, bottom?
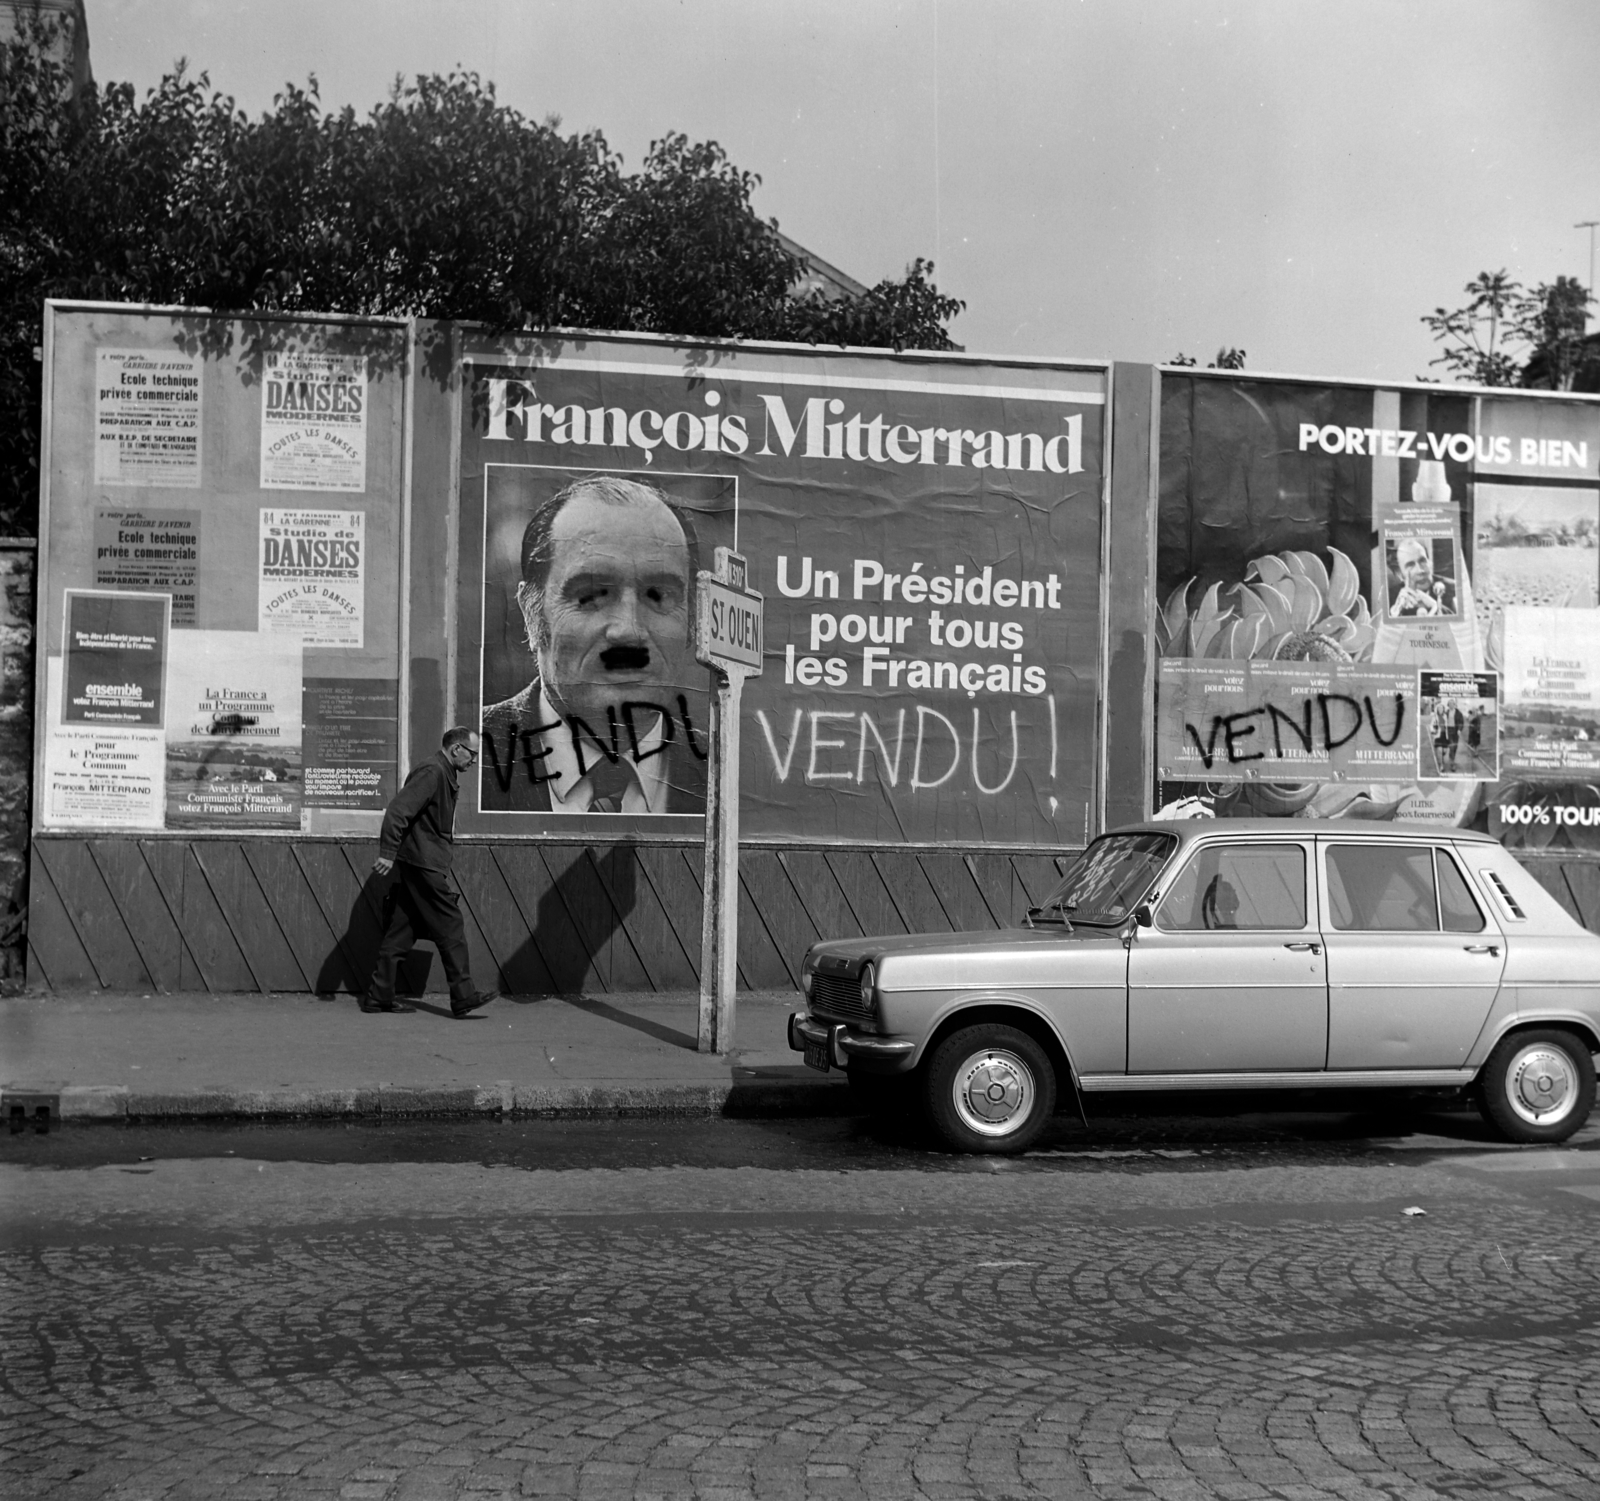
29, 298, 419, 843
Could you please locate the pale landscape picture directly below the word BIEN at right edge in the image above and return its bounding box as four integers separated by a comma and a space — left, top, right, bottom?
1472, 483, 1600, 626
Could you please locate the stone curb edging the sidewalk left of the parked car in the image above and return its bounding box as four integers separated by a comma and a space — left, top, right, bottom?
0, 1079, 850, 1130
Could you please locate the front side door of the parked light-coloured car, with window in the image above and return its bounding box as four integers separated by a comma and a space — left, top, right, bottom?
1128, 839, 1328, 1074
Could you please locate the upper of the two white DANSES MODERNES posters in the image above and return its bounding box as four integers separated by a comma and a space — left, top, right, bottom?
261, 350, 366, 494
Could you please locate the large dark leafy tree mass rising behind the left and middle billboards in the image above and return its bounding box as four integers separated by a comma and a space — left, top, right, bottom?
0, 13, 965, 531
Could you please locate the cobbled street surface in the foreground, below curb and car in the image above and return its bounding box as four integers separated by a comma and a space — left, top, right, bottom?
0, 1103, 1600, 1501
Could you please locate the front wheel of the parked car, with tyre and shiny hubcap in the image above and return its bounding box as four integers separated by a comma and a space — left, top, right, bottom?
925, 1023, 1056, 1154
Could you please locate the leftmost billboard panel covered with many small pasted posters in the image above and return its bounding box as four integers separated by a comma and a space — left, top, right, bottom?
35, 304, 408, 834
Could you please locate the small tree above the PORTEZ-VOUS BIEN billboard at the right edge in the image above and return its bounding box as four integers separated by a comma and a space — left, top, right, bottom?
1422, 269, 1600, 390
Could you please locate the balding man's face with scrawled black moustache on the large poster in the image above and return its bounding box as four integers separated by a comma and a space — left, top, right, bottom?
526, 490, 690, 734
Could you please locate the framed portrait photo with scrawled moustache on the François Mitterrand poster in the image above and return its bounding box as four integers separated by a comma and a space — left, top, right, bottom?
478, 464, 738, 816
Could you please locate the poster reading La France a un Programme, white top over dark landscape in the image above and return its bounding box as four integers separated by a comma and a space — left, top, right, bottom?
166, 630, 302, 829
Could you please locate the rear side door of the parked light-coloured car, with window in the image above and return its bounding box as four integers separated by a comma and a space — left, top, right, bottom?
1320, 839, 1506, 1069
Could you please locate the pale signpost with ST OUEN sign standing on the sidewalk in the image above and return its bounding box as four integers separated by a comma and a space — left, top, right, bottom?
694, 547, 765, 1053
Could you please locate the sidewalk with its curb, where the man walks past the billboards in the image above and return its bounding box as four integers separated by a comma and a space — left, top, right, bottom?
0, 992, 848, 1122
